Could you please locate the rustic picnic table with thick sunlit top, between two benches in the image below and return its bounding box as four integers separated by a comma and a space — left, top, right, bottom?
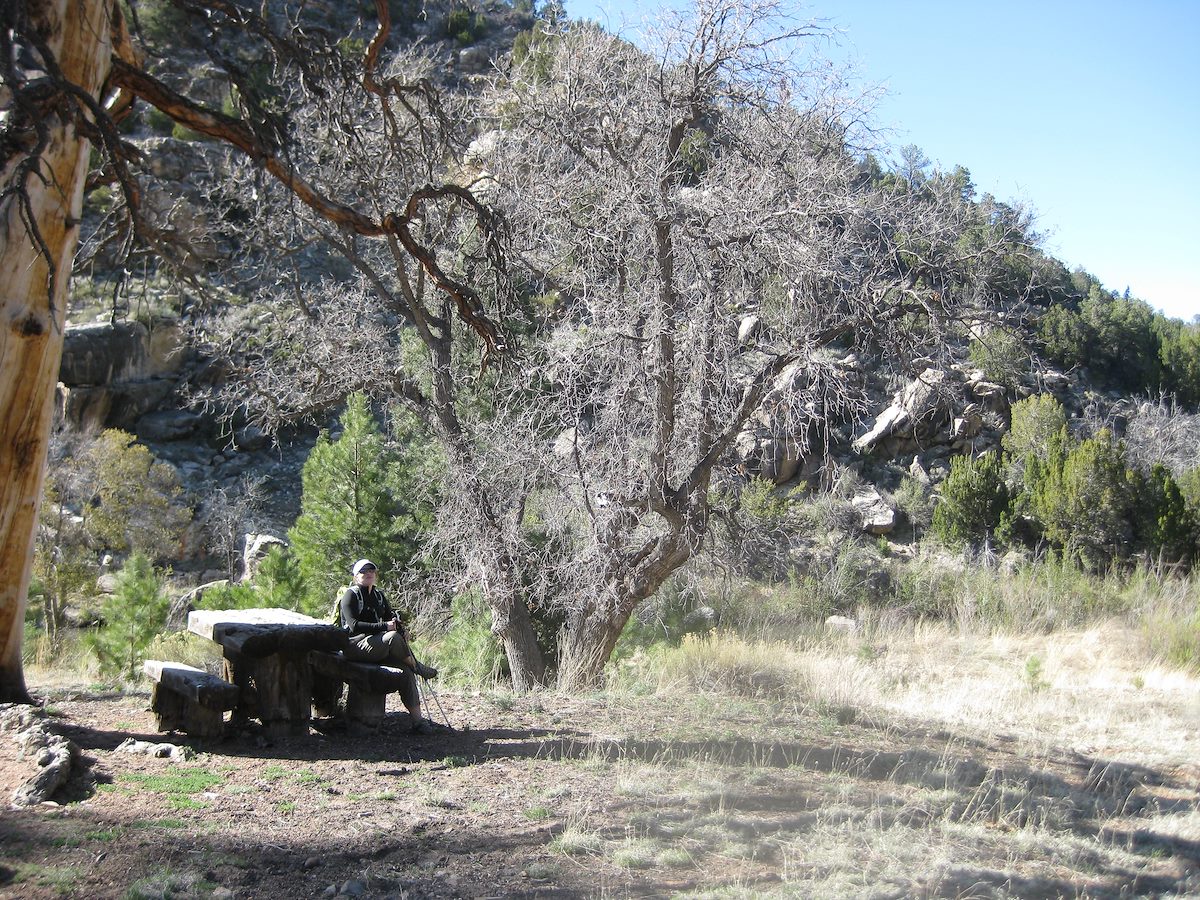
187, 608, 346, 737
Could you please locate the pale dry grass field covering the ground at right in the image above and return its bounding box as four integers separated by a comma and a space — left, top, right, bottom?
595, 614, 1200, 898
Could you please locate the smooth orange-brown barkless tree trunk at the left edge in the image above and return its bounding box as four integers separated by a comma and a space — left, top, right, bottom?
0, 0, 112, 702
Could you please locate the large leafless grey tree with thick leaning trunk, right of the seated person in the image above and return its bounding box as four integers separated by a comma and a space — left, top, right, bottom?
453, 0, 1022, 686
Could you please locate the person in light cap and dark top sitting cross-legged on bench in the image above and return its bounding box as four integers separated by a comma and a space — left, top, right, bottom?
340, 559, 438, 734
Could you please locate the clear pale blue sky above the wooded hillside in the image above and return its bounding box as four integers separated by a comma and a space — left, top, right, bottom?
565, 0, 1200, 320
